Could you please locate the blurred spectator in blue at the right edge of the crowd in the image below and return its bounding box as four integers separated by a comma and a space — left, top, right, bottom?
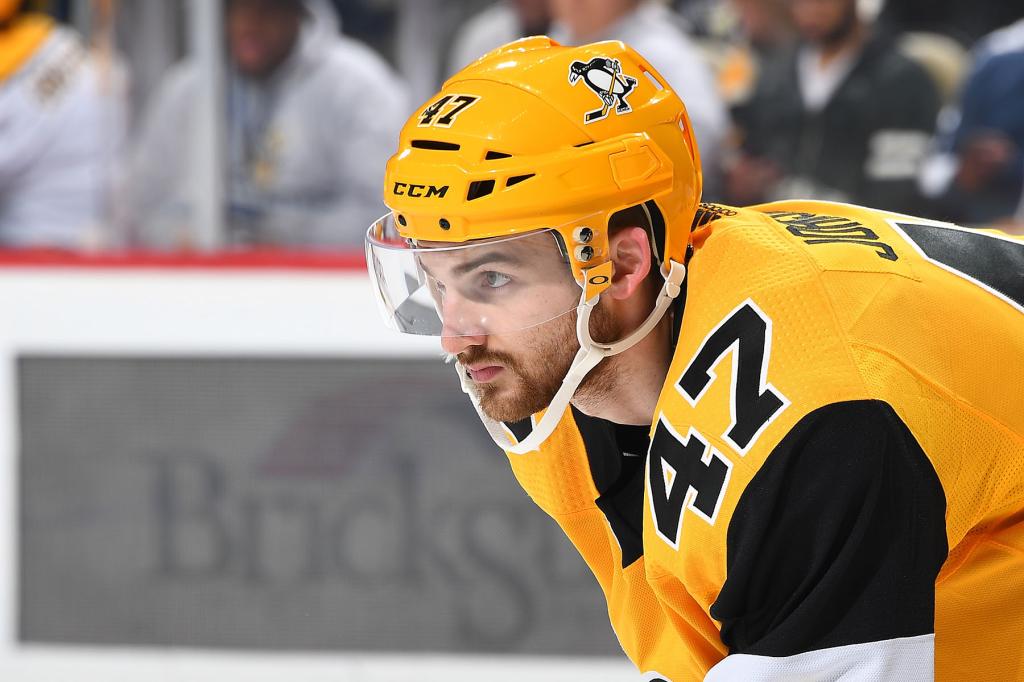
922, 19, 1024, 224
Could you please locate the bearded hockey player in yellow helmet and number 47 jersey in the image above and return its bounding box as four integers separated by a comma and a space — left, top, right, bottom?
367, 38, 1024, 682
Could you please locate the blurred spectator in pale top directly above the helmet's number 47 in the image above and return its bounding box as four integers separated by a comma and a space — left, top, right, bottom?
446, 0, 551, 74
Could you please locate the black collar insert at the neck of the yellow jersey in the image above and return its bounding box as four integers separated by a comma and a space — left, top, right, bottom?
572, 408, 647, 568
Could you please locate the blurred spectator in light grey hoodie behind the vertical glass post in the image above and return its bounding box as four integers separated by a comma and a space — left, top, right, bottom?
127, 0, 407, 248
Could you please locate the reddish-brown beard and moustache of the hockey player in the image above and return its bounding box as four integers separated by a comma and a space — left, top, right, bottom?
459, 304, 622, 422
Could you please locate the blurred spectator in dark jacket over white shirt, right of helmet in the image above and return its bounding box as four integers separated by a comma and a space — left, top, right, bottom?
728, 0, 939, 213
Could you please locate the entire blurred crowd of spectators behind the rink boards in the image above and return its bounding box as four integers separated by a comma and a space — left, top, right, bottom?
0, 0, 1024, 251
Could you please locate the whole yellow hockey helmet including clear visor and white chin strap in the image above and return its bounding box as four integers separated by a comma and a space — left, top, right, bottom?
367, 37, 701, 454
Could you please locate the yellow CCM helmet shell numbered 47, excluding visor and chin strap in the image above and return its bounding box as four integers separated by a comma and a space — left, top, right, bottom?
376, 37, 701, 295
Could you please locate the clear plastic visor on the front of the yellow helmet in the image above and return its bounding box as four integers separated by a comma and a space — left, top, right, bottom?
367, 213, 581, 337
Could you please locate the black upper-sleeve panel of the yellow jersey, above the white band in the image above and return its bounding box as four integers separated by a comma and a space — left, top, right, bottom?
711, 400, 947, 656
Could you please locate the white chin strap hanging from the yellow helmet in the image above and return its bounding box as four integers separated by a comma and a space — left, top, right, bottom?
455, 261, 686, 455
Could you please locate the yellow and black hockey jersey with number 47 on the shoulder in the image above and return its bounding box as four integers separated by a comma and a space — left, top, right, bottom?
509, 202, 1024, 682
